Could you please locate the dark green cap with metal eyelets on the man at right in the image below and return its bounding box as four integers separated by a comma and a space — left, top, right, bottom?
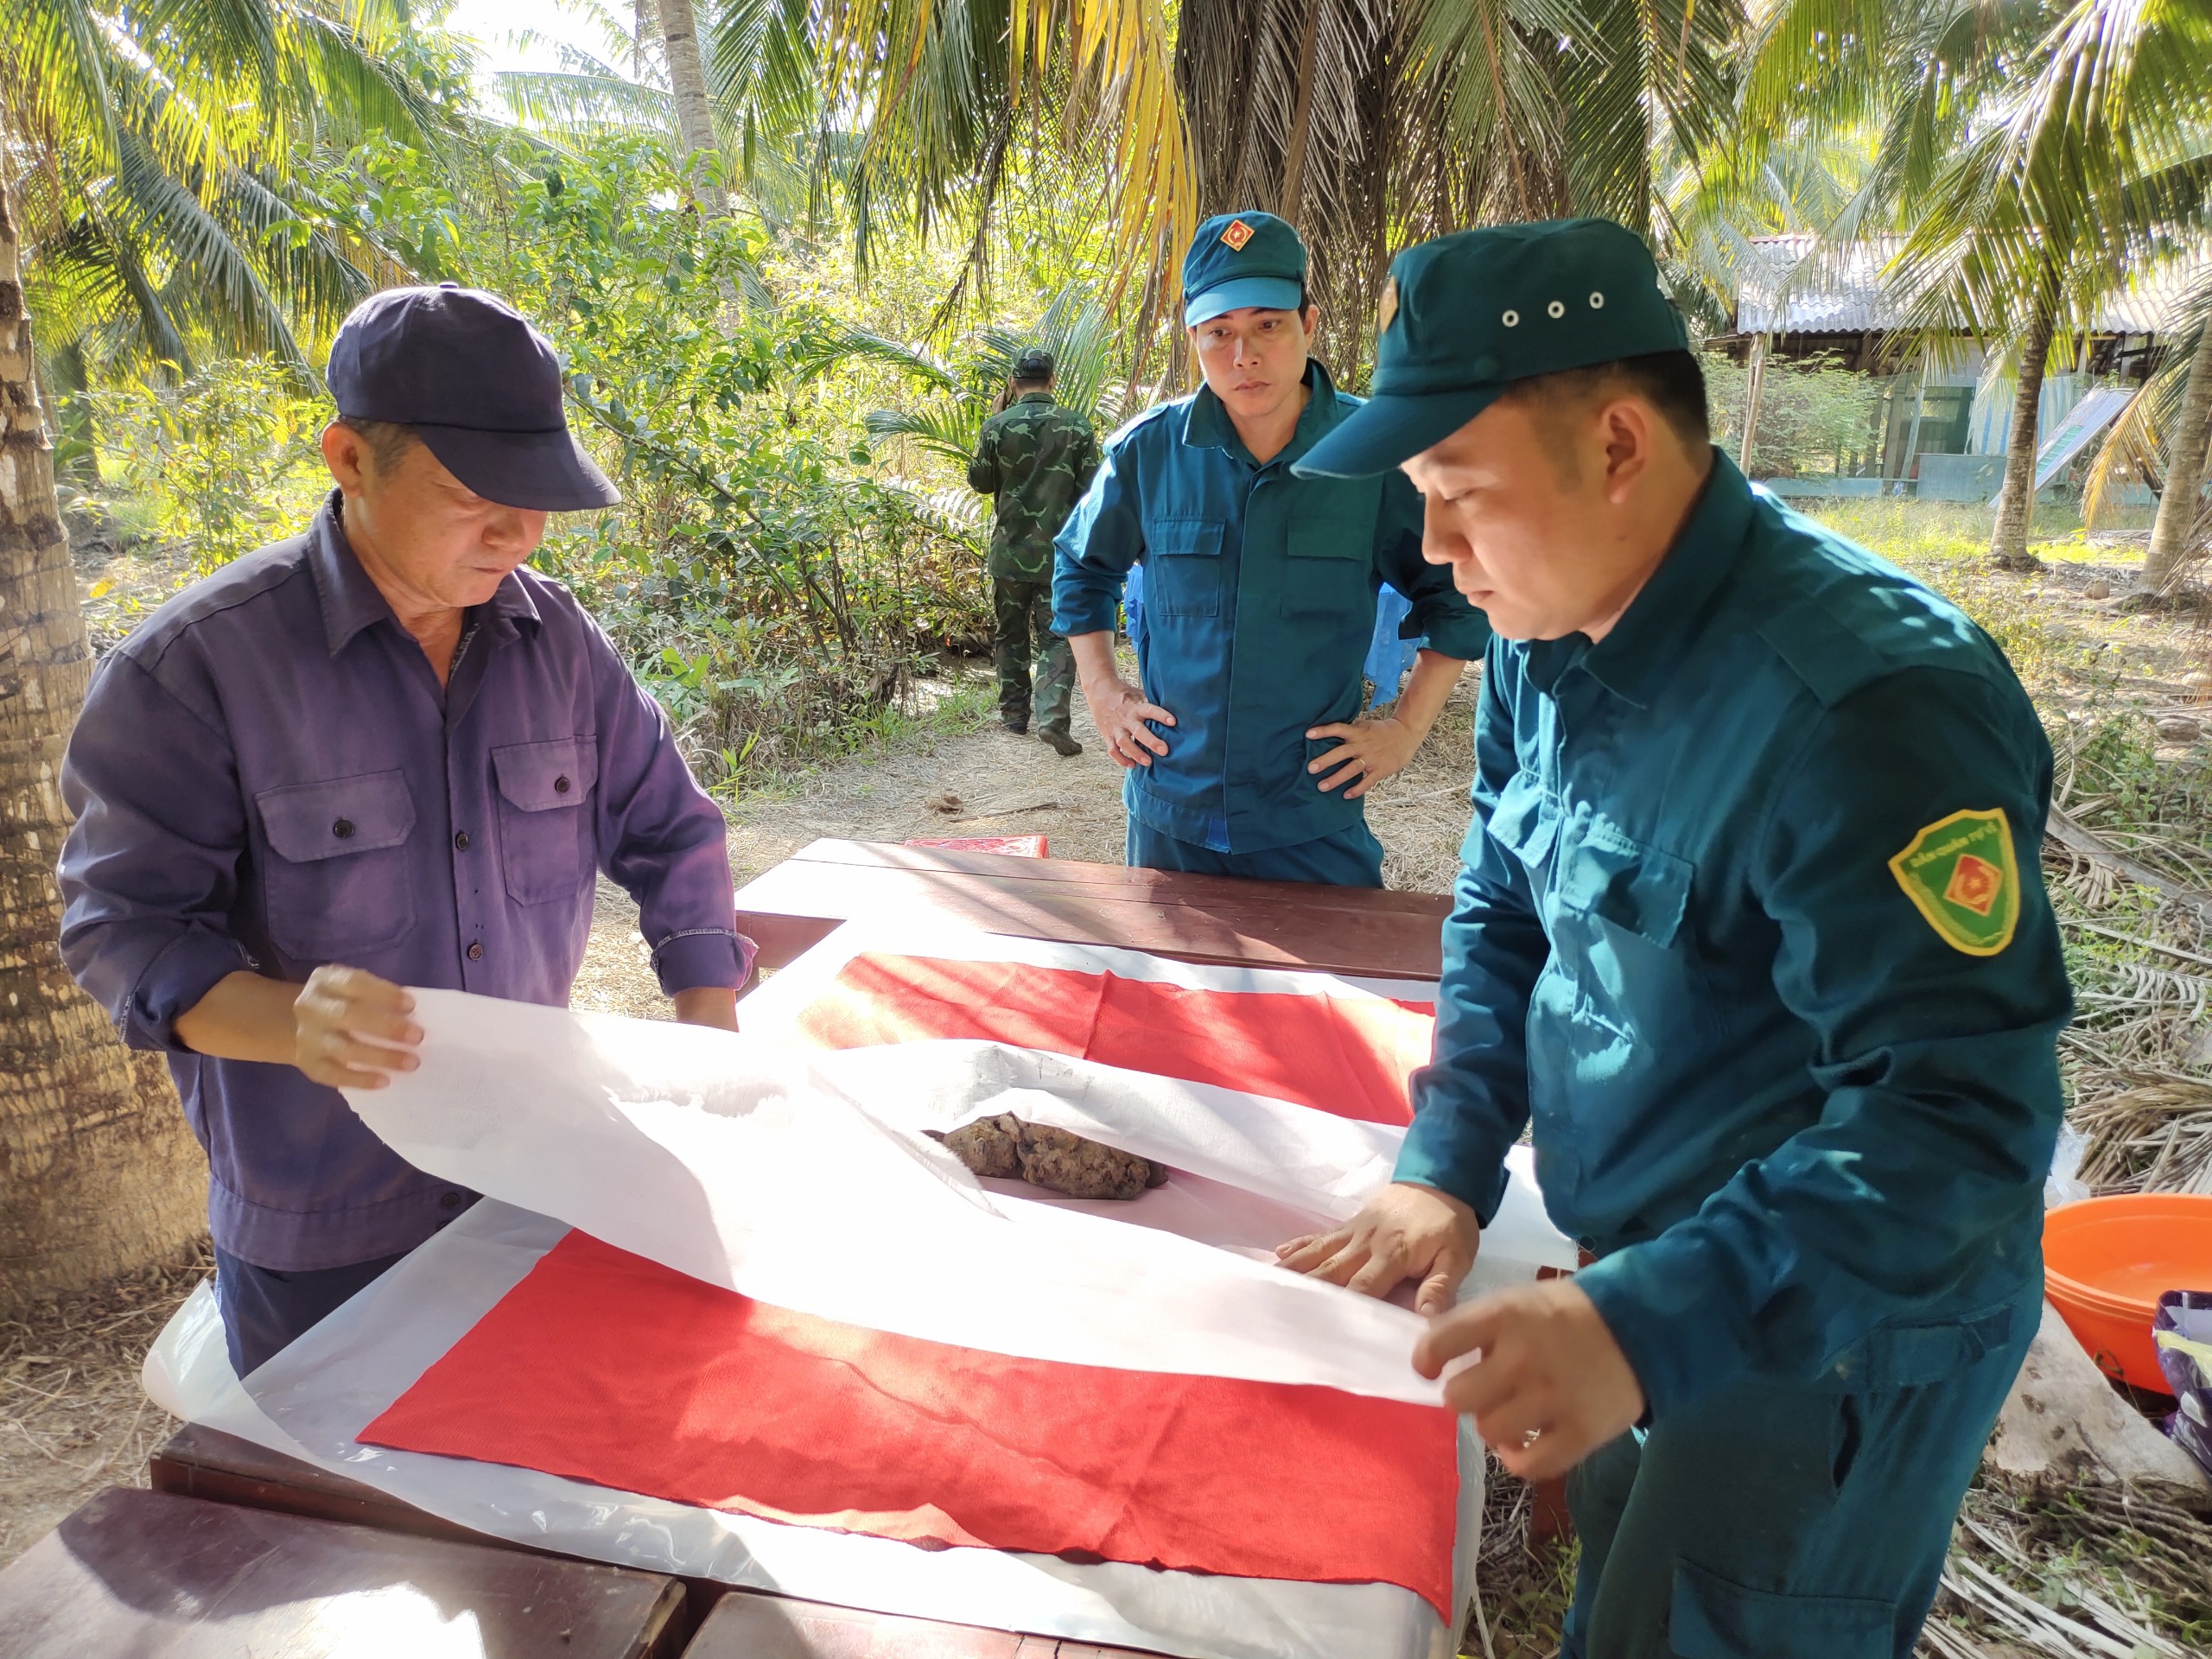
1292, 219, 1690, 478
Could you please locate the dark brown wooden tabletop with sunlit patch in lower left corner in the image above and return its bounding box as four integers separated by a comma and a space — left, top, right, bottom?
0, 1486, 690, 1659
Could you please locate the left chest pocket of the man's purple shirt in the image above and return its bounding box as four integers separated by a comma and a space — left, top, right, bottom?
254, 770, 416, 963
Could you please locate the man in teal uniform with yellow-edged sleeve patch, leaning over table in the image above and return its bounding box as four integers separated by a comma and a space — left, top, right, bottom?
1283, 219, 2070, 1659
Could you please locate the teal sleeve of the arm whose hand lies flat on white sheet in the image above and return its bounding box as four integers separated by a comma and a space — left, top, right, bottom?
1395, 658, 1551, 1225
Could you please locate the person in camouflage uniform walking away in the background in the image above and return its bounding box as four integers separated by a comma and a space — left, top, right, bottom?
969, 349, 1099, 754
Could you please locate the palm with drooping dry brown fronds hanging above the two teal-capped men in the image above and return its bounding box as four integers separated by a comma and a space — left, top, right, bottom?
823, 0, 1743, 372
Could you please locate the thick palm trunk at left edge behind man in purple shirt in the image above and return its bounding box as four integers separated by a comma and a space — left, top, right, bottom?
0, 168, 206, 1312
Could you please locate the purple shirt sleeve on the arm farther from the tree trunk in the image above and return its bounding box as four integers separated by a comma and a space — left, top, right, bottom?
591, 624, 754, 995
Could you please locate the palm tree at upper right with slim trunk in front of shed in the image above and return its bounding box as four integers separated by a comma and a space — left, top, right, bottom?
1743, 0, 2212, 569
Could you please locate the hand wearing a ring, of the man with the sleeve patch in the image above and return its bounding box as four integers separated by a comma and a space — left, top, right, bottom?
1414, 1279, 1643, 1480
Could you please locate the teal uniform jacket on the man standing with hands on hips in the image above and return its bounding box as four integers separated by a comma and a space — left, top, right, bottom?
1053, 363, 1489, 852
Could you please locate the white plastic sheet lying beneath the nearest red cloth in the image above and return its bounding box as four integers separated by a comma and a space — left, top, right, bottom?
146, 1201, 1482, 1659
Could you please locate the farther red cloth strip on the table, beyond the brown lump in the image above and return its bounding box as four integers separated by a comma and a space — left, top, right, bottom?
798, 951, 1435, 1123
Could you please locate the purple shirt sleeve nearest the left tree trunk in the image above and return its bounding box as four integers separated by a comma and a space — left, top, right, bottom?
58, 655, 254, 1051
